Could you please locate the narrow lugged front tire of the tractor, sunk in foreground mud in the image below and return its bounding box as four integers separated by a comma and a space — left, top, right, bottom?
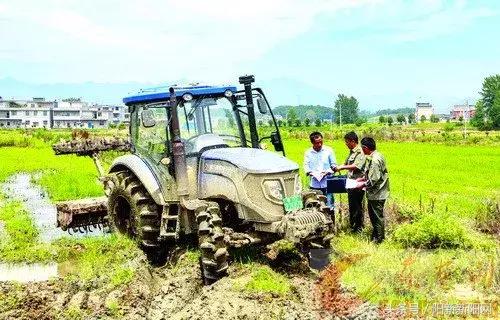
196, 202, 228, 285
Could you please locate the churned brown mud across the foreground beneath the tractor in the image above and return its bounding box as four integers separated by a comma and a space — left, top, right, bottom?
0, 175, 380, 320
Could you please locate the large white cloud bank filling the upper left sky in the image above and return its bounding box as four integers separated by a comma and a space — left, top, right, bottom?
0, 0, 377, 81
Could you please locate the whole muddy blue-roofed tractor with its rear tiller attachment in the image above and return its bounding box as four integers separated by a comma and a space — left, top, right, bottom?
54, 76, 333, 283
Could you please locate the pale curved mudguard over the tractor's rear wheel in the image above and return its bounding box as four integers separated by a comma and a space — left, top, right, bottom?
109, 154, 166, 206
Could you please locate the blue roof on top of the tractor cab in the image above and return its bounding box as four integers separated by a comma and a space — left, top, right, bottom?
123, 86, 236, 106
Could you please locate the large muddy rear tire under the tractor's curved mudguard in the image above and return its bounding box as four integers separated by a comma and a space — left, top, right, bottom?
108, 171, 165, 261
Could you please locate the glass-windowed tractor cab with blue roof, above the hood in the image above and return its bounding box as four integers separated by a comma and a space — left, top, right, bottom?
123, 77, 284, 165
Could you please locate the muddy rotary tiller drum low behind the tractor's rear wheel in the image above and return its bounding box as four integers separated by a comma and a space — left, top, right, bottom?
56, 197, 108, 233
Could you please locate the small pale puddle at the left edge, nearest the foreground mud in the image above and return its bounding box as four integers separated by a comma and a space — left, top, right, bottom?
0, 263, 58, 283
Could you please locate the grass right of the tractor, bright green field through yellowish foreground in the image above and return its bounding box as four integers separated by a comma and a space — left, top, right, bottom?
285, 134, 500, 304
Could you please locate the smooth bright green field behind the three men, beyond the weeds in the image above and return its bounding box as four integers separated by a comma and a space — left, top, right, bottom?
285, 139, 500, 218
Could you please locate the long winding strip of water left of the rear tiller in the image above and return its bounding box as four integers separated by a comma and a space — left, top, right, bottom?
2, 173, 104, 242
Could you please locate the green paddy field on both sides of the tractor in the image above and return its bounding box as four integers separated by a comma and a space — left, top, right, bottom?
0, 128, 500, 314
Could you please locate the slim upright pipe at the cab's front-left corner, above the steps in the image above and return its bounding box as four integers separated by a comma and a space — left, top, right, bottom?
169, 88, 189, 198
